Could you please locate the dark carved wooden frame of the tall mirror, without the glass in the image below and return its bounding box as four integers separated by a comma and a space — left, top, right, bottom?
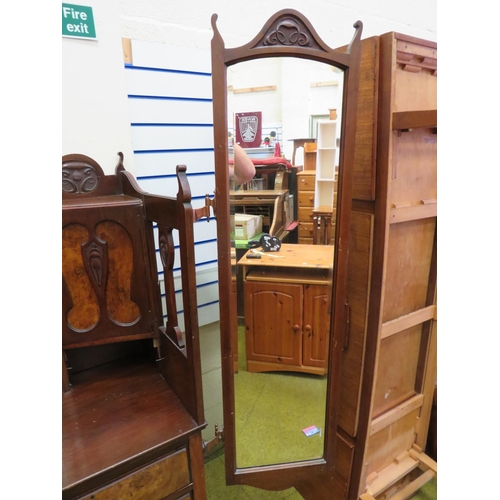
211, 9, 363, 490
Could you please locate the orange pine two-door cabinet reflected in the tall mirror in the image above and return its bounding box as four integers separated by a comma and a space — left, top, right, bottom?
238, 244, 333, 375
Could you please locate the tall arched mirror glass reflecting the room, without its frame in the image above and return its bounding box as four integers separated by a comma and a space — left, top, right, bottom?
227, 57, 344, 468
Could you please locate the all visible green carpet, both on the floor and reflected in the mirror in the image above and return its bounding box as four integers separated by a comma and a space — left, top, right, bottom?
205, 327, 437, 500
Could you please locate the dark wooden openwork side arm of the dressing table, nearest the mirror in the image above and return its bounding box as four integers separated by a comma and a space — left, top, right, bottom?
116, 162, 204, 423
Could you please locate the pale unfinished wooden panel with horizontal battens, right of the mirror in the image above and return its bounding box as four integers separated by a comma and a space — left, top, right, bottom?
350, 32, 437, 499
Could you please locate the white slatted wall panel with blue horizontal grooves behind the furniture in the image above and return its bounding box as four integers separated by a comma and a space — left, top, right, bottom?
125, 40, 219, 330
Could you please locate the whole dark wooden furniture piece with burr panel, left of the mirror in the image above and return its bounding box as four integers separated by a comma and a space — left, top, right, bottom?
62, 154, 206, 500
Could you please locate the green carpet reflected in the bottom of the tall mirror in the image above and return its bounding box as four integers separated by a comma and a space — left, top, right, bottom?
234, 327, 327, 467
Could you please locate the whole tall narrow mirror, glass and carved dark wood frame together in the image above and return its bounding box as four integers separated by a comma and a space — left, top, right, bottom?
211, 9, 362, 490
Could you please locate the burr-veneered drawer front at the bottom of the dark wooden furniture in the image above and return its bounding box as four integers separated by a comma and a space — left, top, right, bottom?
82, 448, 191, 500
